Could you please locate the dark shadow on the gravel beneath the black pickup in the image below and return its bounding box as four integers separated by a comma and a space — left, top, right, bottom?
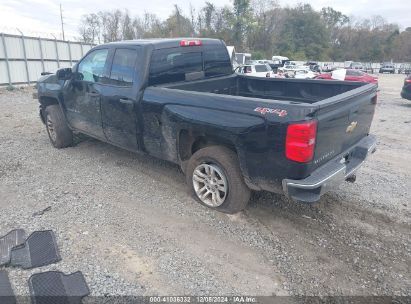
76, 135, 408, 233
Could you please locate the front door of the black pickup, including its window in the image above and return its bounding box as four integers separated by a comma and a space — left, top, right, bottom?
64, 49, 109, 139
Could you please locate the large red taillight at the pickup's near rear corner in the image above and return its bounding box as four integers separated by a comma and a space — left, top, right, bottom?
285, 120, 317, 163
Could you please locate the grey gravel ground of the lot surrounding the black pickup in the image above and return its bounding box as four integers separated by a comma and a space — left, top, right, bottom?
0, 75, 411, 295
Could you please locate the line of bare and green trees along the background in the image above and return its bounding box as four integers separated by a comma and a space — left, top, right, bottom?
79, 0, 411, 62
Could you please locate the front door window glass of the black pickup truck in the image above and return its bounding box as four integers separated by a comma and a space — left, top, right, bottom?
78, 49, 108, 82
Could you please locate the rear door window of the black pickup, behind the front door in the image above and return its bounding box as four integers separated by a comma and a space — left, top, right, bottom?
109, 49, 137, 87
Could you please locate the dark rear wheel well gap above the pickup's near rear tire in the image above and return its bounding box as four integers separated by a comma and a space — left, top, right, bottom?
178, 130, 237, 161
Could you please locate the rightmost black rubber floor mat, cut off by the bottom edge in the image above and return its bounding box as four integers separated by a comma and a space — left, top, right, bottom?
29, 271, 90, 304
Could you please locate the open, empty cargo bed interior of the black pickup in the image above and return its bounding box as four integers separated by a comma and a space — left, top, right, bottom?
163, 74, 367, 104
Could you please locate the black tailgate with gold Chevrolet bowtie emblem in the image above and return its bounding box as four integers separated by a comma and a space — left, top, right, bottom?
312, 84, 377, 169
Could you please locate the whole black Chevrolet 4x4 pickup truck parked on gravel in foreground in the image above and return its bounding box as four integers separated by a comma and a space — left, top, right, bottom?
37, 38, 377, 213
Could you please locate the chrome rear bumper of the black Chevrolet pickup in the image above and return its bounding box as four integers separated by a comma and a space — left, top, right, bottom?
282, 135, 377, 203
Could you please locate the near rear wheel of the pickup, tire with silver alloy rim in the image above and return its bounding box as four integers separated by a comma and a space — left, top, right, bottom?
186, 146, 251, 214
